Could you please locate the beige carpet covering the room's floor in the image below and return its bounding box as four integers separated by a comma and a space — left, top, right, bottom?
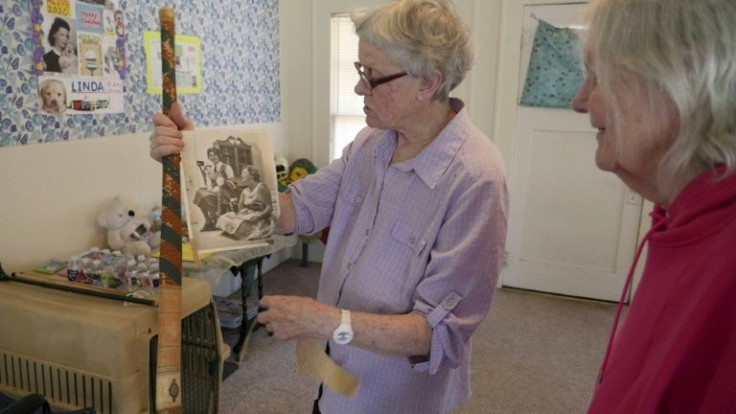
219, 260, 615, 414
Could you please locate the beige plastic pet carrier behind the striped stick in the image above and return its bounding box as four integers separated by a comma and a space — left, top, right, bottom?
0, 278, 229, 414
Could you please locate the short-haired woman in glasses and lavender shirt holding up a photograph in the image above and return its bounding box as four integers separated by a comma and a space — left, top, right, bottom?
150, 0, 508, 414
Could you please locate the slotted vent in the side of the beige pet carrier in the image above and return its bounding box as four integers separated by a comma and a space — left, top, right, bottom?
0, 353, 113, 414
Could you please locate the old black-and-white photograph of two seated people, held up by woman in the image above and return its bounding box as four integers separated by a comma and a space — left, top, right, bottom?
182, 130, 278, 252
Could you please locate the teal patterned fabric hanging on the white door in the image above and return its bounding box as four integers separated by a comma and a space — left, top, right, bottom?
520, 19, 585, 108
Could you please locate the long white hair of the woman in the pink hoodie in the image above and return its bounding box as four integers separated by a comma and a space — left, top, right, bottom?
583, 0, 736, 199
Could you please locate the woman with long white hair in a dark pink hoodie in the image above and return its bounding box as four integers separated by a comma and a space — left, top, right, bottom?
573, 0, 736, 413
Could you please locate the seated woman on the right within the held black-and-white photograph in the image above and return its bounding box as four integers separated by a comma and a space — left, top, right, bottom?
217, 165, 274, 240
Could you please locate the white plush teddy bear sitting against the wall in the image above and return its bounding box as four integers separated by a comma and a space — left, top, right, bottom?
97, 197, 161, 256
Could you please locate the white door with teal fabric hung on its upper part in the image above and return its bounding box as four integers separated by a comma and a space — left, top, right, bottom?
496, 0, 641, 300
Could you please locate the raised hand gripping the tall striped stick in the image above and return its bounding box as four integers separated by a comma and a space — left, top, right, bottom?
149, 102, 194, 161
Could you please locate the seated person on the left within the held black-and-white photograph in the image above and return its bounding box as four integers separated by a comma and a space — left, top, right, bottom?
194, 148, 238, 231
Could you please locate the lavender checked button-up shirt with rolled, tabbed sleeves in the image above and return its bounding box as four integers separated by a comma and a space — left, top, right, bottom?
291, 99, 508, 414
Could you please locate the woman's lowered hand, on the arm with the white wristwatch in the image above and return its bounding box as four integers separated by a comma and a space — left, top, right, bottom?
257, 296, 340, 340
